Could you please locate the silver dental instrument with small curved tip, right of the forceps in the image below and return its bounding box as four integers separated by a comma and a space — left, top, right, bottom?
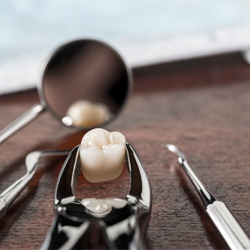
164, 144, 250, 250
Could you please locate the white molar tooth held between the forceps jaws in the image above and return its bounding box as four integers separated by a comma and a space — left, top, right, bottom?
80, 128, 126, 183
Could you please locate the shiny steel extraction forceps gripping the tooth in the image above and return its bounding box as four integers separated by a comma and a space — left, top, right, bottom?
42, 143, 152, 249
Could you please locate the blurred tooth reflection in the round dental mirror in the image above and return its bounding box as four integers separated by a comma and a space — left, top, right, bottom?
67, 100, 110, 127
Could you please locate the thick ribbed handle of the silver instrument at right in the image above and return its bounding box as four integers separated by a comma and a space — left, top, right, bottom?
206, 201, 250, 250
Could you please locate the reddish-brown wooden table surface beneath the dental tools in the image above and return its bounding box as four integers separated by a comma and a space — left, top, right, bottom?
0, 54, 250, 249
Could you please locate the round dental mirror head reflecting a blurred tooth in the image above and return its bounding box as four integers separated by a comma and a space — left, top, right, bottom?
40, 39, 132, 130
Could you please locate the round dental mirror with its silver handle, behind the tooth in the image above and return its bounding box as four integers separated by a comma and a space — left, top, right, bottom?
0, 39, 133, 144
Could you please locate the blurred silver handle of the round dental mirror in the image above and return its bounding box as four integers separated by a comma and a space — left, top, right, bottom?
0, 103, 44, 144
